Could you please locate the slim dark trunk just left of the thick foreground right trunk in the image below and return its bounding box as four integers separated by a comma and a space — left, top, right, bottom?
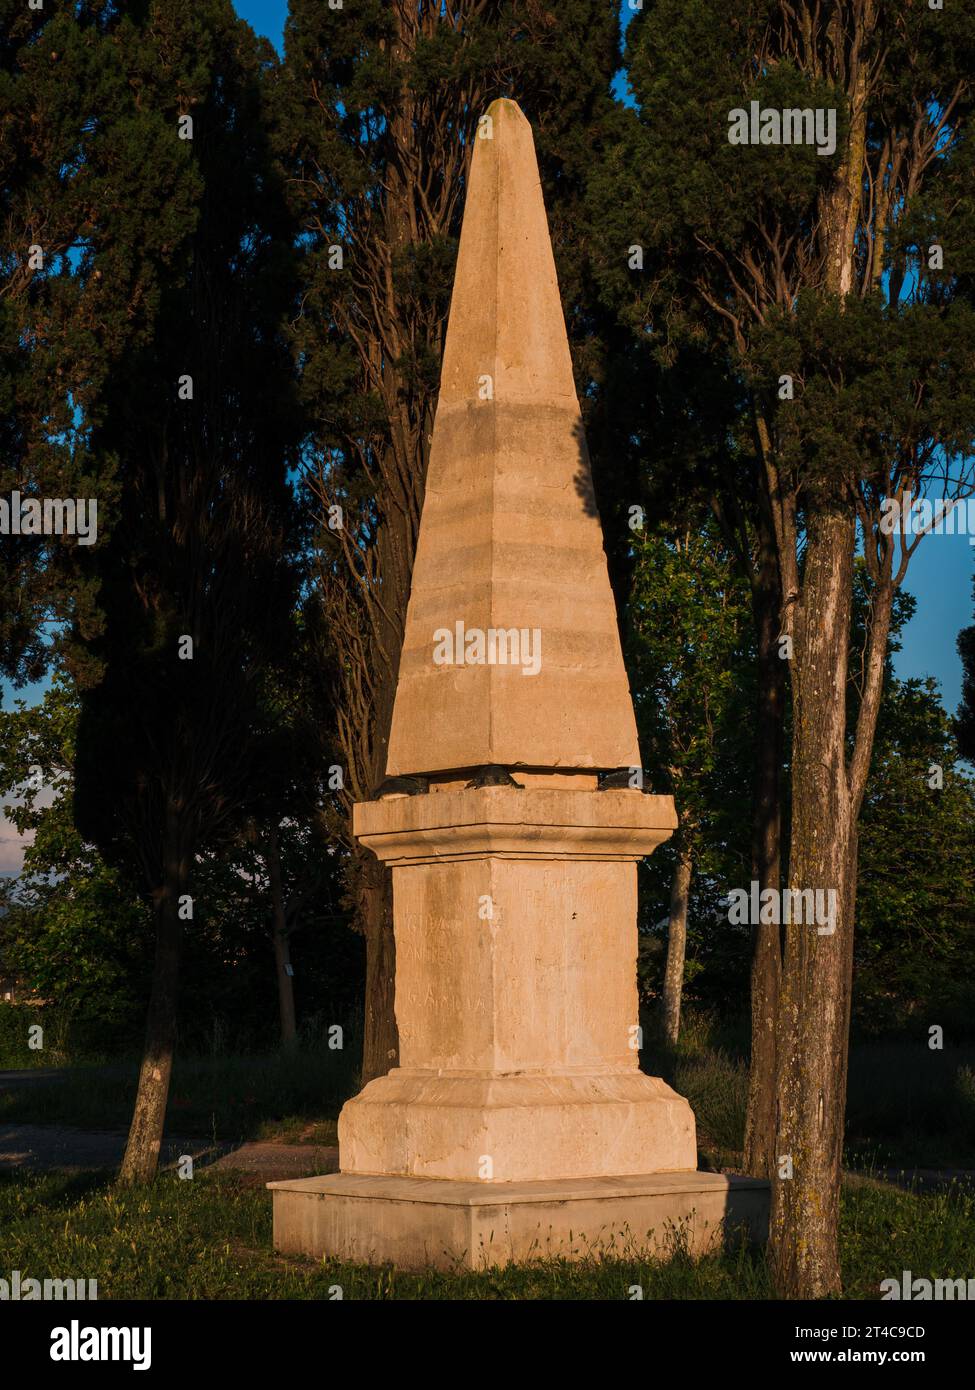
743, 535, 786, 1177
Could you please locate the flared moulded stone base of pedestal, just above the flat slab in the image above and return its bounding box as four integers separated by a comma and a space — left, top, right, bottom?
338, 1070, 697, 1183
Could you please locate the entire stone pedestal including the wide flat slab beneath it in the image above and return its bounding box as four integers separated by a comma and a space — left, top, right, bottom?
273, 787, 764, 1268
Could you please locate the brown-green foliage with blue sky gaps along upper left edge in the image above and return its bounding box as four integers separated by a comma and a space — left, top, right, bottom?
0, 0, 199, 680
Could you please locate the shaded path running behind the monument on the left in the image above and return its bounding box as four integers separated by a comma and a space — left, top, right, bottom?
0, 1125, 338, 1179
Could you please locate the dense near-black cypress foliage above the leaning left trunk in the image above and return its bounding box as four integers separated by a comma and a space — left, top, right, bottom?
75, 0, 300, 894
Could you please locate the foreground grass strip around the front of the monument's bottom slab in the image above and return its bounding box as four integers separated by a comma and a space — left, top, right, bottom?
0, 1173, 975, 1300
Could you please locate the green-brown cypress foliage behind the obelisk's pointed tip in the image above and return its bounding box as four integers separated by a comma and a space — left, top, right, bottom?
274, 0, 619, 458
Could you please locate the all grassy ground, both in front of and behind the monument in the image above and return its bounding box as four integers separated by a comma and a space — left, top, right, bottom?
0, 1019, 975, 1300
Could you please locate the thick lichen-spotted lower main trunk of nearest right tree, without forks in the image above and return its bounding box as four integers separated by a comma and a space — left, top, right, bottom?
769, 512, 857, 1298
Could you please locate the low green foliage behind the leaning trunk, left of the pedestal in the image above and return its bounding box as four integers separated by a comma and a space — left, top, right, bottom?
0, 677, 363, 1065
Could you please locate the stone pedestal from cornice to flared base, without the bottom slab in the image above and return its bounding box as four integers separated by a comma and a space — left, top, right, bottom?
338, 787, 687, 1183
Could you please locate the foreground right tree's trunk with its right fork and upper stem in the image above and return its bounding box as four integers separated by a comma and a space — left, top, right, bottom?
769, 32, 873, 1298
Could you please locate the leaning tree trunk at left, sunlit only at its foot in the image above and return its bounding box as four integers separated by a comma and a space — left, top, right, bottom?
118, 806, 189, 1184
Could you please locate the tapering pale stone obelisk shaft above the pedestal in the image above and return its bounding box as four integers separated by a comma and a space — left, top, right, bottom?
388, 100, 640, 776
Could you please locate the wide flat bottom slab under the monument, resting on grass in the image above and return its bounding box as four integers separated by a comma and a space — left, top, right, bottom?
267, 1172, 769, 1269
